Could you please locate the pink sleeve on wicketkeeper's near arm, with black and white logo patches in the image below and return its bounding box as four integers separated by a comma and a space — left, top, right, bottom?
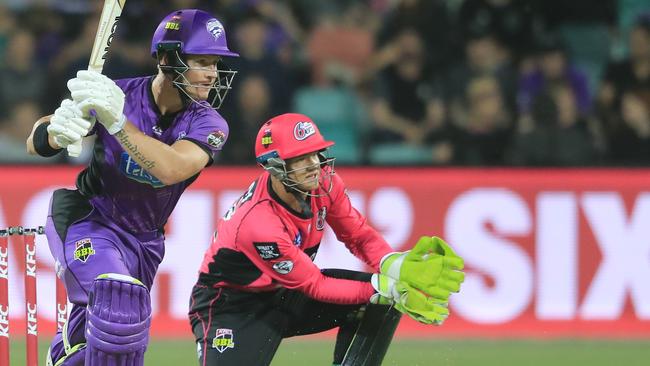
237, 206, 375, 304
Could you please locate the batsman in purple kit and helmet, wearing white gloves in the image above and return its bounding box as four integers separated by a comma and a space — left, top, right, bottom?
27, 9, 238, 366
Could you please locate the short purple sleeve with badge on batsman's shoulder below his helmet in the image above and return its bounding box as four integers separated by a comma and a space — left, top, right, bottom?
183, 109, 230, 165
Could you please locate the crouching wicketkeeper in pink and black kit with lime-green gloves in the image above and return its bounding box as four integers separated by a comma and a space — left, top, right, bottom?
189, 113, 464, 366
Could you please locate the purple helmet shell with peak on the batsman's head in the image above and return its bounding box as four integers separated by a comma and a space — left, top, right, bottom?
151, 9, 239, 57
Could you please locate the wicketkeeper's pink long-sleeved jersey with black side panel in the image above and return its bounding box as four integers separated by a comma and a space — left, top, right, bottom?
199, 168, 392, 304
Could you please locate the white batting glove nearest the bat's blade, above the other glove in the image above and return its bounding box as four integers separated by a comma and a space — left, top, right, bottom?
68, 70, 126, 135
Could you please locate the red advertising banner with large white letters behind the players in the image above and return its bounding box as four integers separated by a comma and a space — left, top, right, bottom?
0, 167, 650, 338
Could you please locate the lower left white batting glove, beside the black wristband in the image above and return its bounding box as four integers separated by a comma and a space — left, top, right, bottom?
47, 99, 94, 148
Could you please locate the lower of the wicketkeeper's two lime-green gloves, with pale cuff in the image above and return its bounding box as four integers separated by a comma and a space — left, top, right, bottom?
370, 273, 449, 325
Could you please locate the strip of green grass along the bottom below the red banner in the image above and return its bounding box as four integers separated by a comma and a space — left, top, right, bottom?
11, 339, 650, 366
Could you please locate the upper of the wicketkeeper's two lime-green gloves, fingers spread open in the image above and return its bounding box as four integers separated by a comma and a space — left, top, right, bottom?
380, 236, 465, 302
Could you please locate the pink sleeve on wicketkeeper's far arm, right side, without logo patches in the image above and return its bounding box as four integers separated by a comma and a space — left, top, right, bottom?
326, 175, 393, 271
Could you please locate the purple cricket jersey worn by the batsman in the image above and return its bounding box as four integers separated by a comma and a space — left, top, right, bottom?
77, 77, 228, 234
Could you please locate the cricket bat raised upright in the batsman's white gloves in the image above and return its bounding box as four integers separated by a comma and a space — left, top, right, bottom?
68, 0, 126, 157
